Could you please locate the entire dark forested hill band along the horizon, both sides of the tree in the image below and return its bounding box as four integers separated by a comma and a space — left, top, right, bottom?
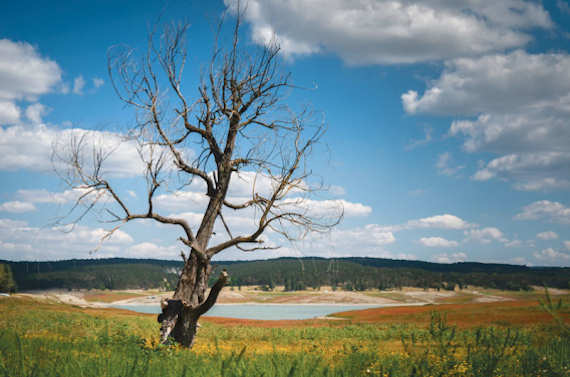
0, 257, 570, 290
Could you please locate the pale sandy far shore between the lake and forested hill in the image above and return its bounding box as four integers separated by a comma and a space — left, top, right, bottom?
17, 286, 556, 308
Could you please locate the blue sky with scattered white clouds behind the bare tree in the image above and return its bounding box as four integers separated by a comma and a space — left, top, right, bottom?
0, 0, 570, 266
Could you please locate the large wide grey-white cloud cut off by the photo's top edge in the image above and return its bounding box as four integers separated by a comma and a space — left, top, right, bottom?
224, 0, 552, 65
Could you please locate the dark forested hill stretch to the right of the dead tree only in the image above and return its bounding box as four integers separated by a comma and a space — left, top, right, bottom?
213, 257, 570, 290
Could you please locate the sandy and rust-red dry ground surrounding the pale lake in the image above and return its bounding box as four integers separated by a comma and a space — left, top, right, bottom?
10, 287, 570, 328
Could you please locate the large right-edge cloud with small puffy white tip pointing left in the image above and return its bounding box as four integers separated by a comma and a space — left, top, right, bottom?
402, 50, 570, 116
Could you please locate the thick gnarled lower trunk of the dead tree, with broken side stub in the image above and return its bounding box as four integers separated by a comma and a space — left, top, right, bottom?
158, 253, 228, 347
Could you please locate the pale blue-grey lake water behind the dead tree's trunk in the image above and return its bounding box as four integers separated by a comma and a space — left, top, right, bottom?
113, 304, 386, 320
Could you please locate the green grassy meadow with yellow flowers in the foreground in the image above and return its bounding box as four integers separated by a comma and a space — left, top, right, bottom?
0, 295, 570, 377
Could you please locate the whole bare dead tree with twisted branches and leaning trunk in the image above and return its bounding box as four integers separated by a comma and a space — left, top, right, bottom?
55, 15, 342, 347
